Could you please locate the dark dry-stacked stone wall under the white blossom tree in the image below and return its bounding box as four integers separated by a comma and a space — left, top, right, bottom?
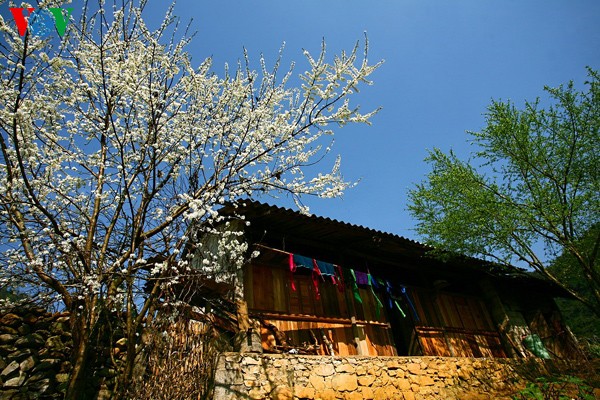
0, 309, 71, 400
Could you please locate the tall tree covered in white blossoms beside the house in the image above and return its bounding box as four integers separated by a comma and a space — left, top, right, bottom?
0, 0, 379, 398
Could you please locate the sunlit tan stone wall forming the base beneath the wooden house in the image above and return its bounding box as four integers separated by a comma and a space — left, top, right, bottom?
214, 353, 546, 400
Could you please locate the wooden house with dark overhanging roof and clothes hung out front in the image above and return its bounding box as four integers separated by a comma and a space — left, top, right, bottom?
196, 200, 576, 358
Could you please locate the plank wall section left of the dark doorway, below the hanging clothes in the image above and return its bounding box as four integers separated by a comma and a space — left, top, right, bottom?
244, 263, 397, 355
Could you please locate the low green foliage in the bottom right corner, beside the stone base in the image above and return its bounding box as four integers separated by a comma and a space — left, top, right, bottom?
512, 375, 596, 400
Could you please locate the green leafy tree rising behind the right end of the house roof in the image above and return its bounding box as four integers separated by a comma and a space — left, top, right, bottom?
409, 68, 600, 315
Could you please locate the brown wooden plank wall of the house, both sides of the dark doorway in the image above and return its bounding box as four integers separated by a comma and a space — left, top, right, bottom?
244, 264, 506, 357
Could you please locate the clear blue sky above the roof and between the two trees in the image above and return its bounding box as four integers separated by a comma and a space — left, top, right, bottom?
142, 0, 600, 239
